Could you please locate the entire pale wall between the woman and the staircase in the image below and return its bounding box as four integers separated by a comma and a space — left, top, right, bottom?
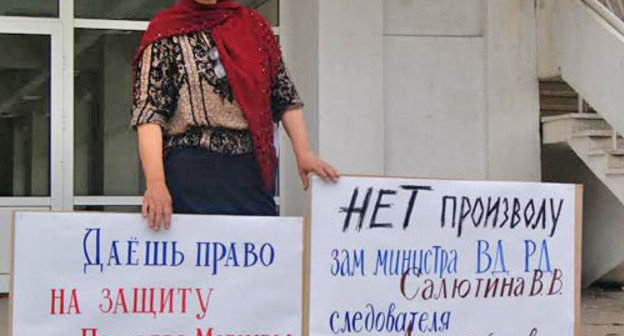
281, 0, 540, 214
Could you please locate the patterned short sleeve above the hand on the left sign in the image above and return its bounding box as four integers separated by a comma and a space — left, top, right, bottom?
130, 38, 178, 128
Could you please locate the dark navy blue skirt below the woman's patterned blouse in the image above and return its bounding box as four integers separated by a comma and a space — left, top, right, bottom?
165, 147, 278, 216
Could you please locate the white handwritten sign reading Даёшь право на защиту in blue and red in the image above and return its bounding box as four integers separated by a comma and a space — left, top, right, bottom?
10, 212, 303, 336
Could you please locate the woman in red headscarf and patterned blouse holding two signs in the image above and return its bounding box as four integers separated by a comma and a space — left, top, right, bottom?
131, 0, 338, 230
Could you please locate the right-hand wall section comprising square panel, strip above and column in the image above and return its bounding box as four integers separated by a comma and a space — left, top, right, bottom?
385, 0, 540, 181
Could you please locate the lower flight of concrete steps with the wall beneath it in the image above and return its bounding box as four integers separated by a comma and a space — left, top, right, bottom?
540, 79, 624, 286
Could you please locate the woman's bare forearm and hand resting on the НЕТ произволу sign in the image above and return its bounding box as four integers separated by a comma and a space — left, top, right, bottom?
282, 109, 340, 190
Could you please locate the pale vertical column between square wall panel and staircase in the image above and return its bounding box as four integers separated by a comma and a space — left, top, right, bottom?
486, 0, 541, 181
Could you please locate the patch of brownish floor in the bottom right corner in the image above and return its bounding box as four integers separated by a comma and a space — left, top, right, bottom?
581, 288, 624, 336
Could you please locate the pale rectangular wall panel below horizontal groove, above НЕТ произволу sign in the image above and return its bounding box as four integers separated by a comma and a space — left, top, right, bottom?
385, 36, 487, 179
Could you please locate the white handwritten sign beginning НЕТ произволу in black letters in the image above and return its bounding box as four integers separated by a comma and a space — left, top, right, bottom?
307, 177, 581, 336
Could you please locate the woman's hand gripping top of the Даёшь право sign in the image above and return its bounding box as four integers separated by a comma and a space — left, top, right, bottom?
141, 181, 173, 231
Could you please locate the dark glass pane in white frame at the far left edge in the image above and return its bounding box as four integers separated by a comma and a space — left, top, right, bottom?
0, 34, 50, 196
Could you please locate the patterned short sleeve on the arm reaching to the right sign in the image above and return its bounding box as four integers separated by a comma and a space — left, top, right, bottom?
271, 57, 304, 122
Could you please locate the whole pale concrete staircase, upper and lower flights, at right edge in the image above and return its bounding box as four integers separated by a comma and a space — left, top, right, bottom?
537, 0, 624, 286
